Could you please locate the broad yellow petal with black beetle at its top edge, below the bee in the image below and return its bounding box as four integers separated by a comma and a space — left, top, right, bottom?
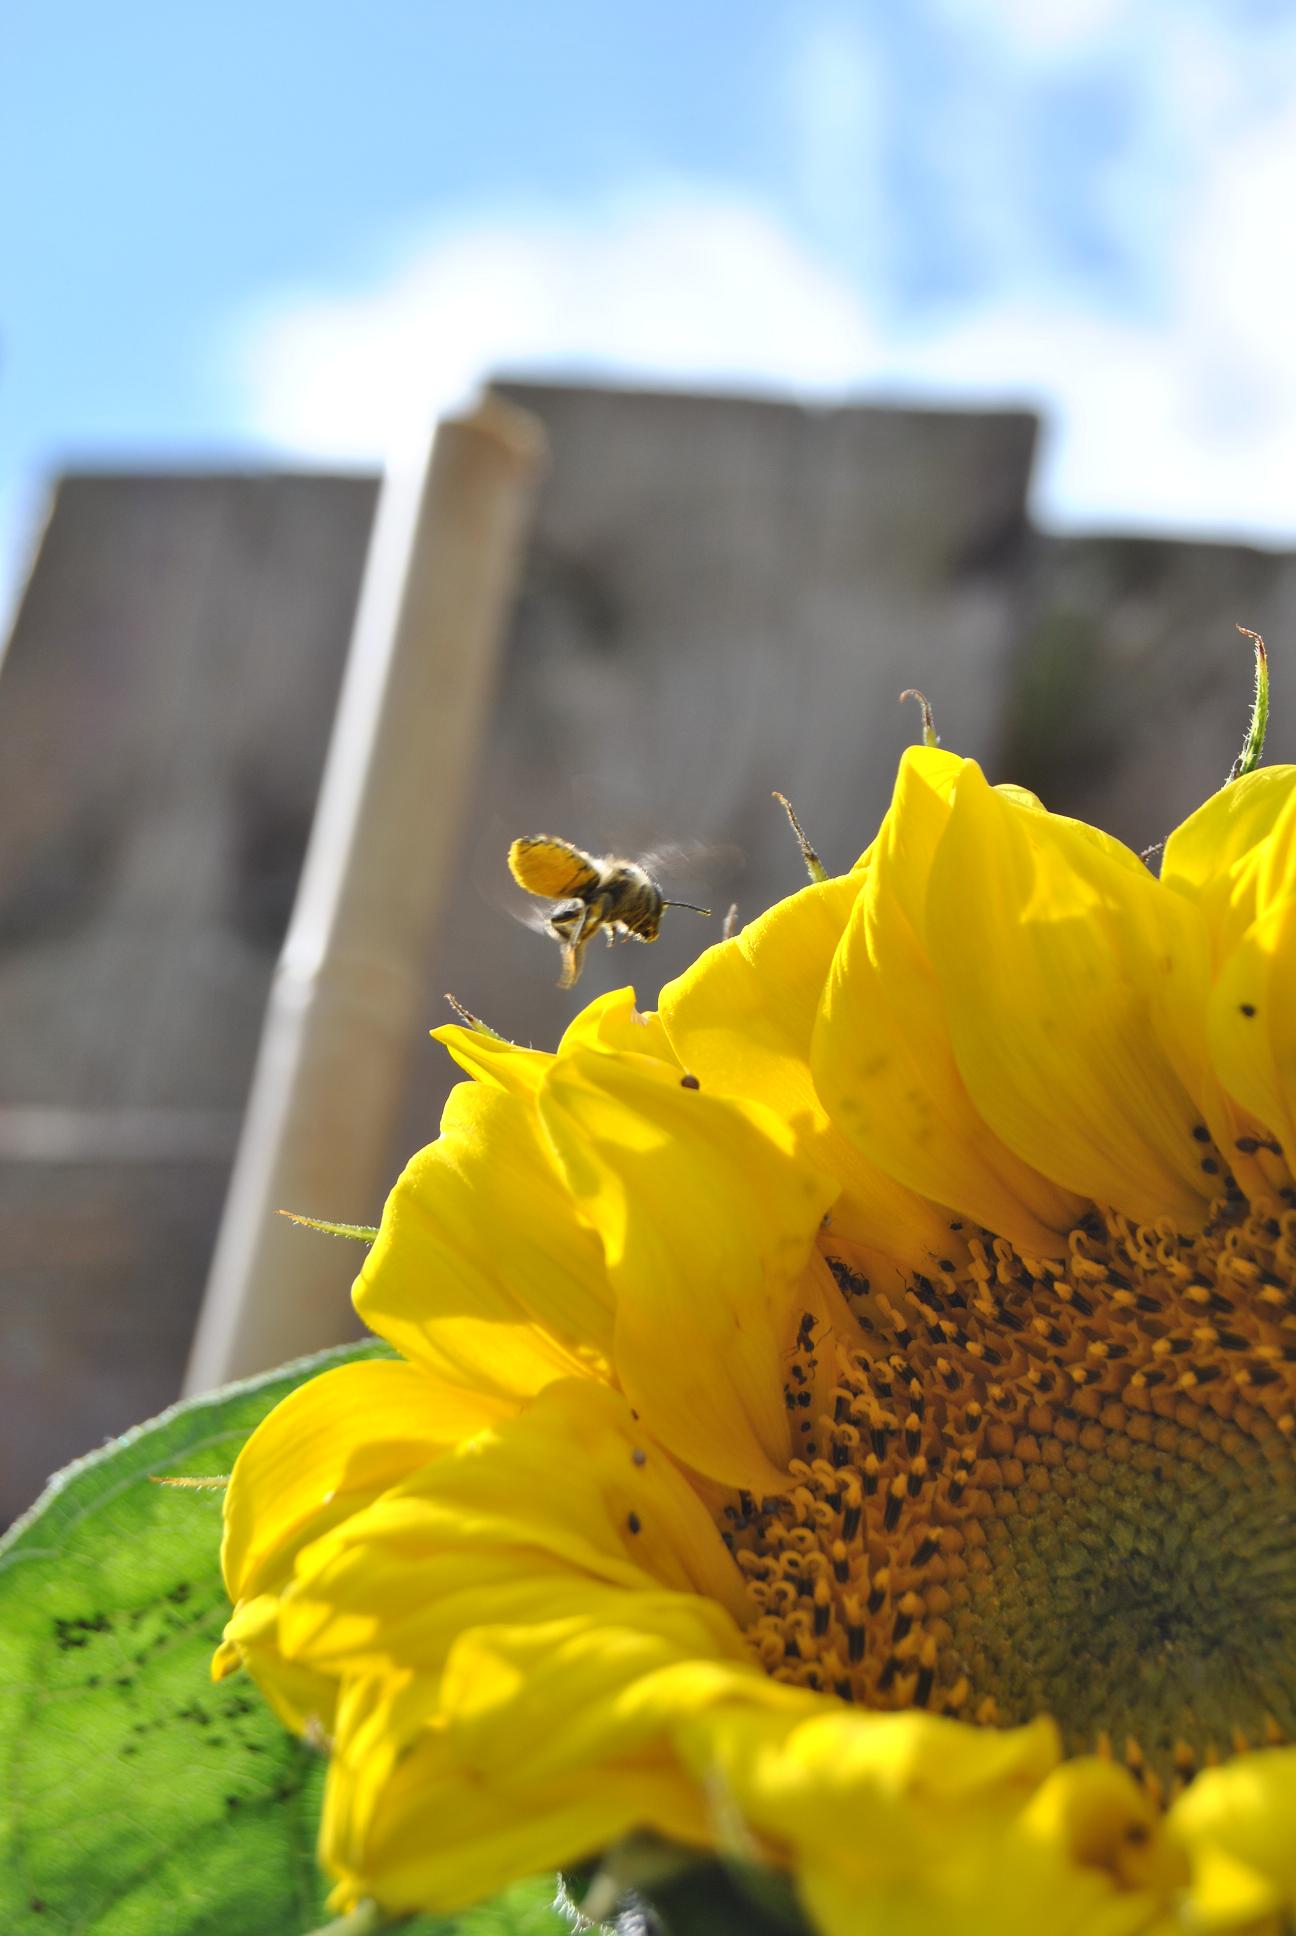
540, 1049, 833, 1493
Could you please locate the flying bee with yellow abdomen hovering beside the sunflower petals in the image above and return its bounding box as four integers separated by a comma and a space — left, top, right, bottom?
508, 834, 711, 987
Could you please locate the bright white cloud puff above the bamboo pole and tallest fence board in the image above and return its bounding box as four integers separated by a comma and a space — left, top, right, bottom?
234, 190, 878, 459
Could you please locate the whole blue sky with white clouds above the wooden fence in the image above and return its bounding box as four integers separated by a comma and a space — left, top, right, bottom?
0, 0, 1296, 619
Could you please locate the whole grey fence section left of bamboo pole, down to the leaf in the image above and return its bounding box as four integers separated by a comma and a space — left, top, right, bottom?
0, 474, 376, 1518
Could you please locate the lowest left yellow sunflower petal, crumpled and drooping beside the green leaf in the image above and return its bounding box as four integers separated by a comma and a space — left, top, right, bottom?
322, 1591, 809, 1909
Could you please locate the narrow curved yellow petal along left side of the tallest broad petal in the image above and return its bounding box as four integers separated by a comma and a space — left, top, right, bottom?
812, 747, 1085, 1256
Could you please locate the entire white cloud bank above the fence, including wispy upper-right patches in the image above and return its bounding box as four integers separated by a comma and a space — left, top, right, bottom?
224, 0, 1296, 542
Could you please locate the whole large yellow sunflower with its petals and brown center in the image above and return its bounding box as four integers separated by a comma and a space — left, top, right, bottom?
217, 745, 1296, 1936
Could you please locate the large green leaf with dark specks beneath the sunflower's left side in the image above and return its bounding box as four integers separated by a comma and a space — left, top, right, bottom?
0, 1344, 568, 1936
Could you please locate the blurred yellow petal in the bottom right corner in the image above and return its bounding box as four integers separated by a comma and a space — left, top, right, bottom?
1168, 1748, 1296, 1932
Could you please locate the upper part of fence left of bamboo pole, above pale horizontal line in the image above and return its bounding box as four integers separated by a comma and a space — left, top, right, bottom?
0, 476, 374, 1107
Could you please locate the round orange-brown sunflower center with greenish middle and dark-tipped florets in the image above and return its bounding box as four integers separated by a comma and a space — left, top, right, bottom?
725, 1193, 1296, 1795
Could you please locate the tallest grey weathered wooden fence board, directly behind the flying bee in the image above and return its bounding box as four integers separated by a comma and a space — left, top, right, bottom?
405, 383, 1036, 1148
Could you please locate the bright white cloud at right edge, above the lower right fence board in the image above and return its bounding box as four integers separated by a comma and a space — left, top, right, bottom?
901, 58, 1296, 544
